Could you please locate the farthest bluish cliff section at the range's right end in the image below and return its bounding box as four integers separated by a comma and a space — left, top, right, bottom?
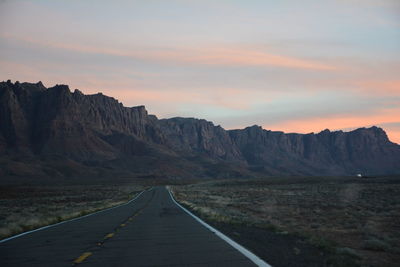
229, 126, 400, 175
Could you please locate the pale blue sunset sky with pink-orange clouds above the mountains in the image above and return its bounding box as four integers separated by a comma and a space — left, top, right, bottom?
0, 0, 400, 143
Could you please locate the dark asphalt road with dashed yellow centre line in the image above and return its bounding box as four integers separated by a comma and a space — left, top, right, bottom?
0, 187, 256, 267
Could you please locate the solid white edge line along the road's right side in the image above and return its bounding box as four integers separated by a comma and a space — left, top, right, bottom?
168, 190, 272, 267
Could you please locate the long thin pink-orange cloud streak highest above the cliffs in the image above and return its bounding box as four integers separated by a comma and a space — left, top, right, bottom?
1, 34, 336, 71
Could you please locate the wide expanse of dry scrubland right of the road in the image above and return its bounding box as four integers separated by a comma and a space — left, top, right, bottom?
172, 177, 400, 267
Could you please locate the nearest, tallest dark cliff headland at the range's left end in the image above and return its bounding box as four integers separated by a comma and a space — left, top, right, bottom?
0, 82, 162, 161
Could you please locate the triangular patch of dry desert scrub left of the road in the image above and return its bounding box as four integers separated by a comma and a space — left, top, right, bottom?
0, 185, 145, 239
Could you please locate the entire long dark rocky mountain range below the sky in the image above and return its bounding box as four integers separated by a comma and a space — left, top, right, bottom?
0, 81, 400, 182
